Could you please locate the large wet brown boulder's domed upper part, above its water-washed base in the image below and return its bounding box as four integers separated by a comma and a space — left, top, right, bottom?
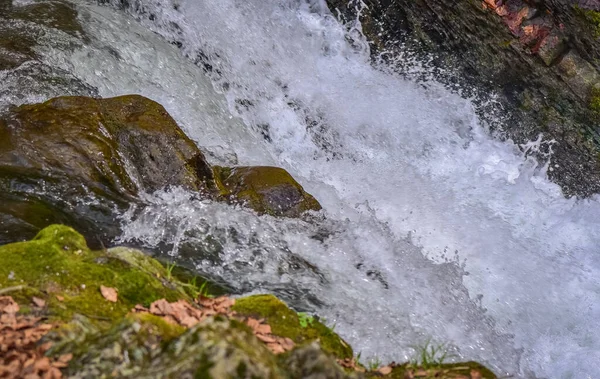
0, 95, 212, 197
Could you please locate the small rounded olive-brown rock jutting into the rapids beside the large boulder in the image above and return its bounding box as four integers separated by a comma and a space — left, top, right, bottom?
213, 166, 321, 217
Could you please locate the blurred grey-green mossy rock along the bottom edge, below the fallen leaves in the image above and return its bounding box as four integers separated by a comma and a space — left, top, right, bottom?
49, 315, 286, 379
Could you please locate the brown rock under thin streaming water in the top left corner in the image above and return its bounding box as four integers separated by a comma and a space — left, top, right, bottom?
0, 0, 98, 108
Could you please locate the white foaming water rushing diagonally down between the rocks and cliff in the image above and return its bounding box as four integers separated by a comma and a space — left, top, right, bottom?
0, 0, 600, 378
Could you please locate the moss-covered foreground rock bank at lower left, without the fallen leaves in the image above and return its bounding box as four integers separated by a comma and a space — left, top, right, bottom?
0, 225, 495, 379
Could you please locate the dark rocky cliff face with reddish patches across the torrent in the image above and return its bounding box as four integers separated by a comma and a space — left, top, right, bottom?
327, 0, 600, 197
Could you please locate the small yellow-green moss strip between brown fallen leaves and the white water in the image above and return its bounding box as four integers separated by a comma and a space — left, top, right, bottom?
233, 295, 353, 359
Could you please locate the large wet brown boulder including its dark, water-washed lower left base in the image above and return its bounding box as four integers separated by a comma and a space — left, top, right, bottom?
0, 96, 212, 246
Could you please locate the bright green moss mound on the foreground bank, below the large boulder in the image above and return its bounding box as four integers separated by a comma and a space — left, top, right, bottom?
0, 225, 188, 321
